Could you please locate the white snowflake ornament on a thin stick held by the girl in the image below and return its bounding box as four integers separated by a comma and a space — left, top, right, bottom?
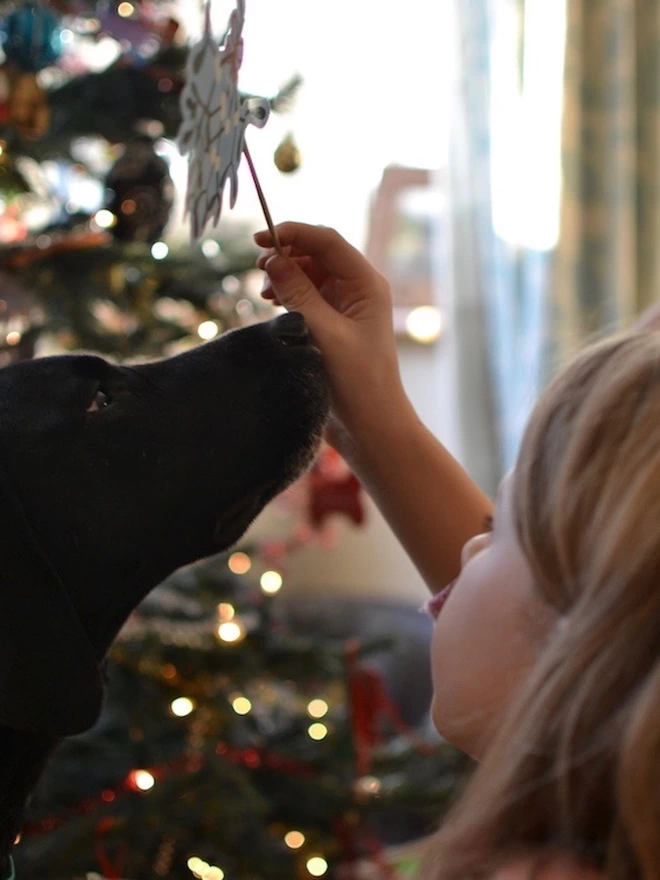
177, 0, 270, 241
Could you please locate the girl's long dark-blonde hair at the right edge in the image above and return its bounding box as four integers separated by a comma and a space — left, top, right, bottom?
423, 333, 660, 880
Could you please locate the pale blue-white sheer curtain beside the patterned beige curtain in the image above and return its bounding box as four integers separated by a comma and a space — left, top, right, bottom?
447, 0, 564, 494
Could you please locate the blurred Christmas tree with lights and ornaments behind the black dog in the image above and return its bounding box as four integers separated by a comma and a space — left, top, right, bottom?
0, 0, 465, 880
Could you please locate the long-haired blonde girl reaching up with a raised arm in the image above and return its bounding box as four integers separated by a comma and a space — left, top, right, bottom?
256, 224, 660, 880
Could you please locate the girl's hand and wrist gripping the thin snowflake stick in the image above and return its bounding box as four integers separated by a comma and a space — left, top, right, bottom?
255, 223, 409, 453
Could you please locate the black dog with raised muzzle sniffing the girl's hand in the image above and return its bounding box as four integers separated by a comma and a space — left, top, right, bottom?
0, 314, 328, 878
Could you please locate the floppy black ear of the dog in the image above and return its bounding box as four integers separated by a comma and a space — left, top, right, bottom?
0, 475, 103, 738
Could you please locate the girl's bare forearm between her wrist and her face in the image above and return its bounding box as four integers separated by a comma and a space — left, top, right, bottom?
340, 404, 493, 593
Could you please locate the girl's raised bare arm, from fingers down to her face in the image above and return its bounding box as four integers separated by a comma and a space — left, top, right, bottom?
256, 223, 492, 592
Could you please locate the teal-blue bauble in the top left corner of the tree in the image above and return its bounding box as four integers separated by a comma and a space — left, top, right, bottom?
0, 0, 62, 73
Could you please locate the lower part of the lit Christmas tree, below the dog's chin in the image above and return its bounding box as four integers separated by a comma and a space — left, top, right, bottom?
17, 550, 466, 880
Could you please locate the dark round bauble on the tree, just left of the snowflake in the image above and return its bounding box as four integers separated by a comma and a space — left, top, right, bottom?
105, 135, 174, 244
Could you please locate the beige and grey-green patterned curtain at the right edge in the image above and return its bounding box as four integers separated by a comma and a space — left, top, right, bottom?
548, 0, 660, 362
